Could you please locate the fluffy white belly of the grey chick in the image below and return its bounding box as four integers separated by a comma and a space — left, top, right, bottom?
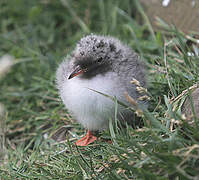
61, 73, 124, 130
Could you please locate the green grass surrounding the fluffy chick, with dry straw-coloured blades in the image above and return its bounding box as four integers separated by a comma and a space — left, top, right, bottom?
0, 0, 199, 180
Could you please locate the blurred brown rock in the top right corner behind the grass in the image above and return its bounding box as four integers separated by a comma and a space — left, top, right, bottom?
140, 0, 199, 33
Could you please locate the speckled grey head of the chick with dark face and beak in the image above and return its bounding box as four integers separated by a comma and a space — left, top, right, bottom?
68, 35, 119, 79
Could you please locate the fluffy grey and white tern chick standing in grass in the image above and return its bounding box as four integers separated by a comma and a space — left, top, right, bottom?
56, 34, 146, 146
